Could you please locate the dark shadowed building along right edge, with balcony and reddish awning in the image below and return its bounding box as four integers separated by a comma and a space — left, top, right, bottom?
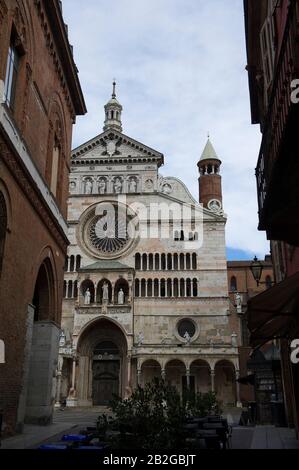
244, 0, 299, 431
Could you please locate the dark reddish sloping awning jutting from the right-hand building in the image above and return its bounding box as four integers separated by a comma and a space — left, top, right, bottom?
247, 272, 299, 347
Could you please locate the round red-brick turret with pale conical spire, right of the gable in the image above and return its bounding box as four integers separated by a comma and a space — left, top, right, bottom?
197, 136, 222, 212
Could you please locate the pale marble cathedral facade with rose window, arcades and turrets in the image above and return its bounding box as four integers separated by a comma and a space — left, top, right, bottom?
56, 84, 240, 406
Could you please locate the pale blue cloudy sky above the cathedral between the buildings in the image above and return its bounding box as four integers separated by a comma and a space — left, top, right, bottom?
63, 0, 269, 259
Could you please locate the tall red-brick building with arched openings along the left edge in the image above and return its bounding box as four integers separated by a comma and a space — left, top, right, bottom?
0, 0, 86, 434
